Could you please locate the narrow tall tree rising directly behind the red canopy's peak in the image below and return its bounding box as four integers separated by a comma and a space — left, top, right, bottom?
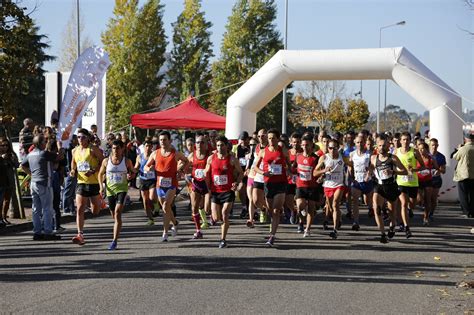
167, 0, 213, 105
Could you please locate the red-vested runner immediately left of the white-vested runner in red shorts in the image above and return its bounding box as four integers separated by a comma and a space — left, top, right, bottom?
295, 137, 321, 237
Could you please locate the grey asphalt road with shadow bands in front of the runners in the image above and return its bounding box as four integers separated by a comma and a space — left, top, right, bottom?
0, 202, 474, 314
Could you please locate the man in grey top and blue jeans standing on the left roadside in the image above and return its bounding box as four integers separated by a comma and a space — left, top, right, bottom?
21, 135, 62, 241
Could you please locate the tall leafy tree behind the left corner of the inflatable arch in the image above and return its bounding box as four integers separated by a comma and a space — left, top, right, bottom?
210, 0, 283, 131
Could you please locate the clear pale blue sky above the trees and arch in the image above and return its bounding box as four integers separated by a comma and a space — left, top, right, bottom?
20, 0, 474, 113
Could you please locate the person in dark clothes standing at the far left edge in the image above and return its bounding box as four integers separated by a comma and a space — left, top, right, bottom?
0, 138, 19, 225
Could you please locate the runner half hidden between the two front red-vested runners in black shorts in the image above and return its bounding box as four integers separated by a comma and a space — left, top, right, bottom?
285, 133, 303, 227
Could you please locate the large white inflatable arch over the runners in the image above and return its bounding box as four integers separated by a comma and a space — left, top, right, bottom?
226, 47, 462, 201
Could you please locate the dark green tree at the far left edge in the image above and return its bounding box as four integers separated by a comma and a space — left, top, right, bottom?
0, 1, 53, 133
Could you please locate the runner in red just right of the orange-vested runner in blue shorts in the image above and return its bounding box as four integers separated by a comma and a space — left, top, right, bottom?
187, 133, 209, 239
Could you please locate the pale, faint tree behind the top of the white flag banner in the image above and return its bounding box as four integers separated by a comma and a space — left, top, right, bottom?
59, 8, 93, 72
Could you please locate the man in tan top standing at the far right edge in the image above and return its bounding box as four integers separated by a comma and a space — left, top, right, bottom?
453, 130, 474, 218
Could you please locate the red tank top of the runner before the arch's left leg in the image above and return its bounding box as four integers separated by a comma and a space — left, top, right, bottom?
211, 153, 234, 193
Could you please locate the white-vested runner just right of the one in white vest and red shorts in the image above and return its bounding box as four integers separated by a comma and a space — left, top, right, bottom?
349, 136, 374, 231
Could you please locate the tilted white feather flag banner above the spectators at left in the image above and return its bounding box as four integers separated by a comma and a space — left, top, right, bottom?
57, 46, 110, 148
